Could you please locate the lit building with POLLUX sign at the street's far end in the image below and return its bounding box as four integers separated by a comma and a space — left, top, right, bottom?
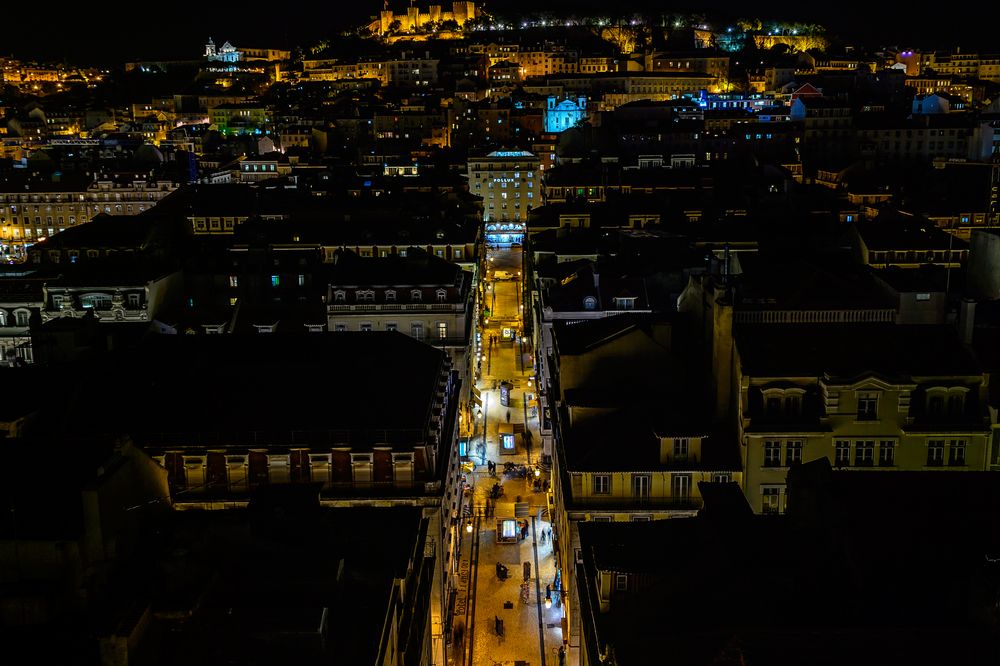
468, 150, 542, 246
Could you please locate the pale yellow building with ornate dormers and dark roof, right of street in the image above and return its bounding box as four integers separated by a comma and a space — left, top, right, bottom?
733, 323, 990, 513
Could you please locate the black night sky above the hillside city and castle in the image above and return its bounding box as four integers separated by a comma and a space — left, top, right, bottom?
0, 0, 995, 64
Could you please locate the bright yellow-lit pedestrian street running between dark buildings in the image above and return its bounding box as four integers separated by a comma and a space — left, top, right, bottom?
449, 247, 563, 666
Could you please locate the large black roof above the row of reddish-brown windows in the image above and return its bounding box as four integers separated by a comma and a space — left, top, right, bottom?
48, 332, 445, 445
